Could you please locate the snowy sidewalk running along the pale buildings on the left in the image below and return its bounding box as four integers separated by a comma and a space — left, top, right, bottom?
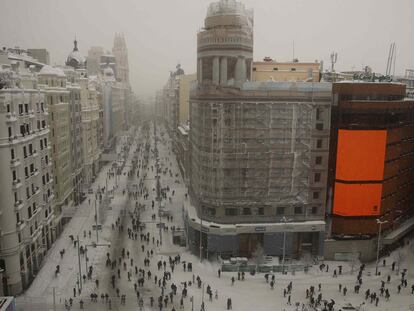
17, 130, 137, 306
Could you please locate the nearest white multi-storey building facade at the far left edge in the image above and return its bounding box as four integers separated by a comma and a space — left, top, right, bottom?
0, 58, 56, 295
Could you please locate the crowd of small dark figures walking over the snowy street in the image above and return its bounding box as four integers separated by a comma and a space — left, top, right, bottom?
55, 123, 414, 311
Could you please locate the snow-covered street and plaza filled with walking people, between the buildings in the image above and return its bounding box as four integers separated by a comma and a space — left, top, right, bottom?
17, 124, 414, 311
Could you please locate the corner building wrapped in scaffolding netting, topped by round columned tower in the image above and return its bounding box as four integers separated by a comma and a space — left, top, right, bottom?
184, 1, 331, 258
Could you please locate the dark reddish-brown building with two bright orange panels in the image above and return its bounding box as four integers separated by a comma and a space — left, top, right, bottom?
328, 82, 414, 260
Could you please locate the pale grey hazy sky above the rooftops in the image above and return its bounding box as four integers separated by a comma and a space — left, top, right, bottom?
0, 0, 414, 96
